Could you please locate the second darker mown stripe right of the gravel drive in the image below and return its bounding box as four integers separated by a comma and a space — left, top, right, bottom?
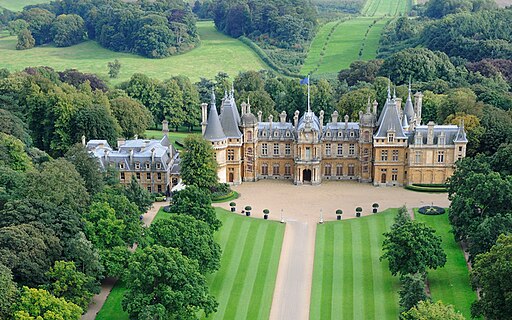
343, 222, 354, 319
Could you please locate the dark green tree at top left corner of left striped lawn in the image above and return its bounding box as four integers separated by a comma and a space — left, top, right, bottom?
171, 185, 222, 230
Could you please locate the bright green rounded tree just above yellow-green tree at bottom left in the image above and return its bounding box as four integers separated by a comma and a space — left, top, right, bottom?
43, 261, 99, 310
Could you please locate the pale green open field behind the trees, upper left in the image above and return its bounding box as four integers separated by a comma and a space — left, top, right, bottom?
0, 21, 268, 84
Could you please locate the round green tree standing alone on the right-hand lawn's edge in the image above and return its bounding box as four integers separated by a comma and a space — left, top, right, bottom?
381, 219, 446, 275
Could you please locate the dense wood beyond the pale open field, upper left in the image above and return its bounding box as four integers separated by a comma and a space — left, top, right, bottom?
12, 0, 198, 58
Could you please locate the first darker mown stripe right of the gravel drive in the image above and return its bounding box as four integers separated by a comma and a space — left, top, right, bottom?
320, 223, 334, 319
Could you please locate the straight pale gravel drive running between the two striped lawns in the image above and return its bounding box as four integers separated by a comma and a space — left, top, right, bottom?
270, 219, 316, 320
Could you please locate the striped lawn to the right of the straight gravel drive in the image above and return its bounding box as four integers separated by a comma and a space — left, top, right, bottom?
310, 209, 399, 320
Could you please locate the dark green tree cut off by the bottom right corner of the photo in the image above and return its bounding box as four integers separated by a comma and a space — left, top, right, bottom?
471, 235, 512, 320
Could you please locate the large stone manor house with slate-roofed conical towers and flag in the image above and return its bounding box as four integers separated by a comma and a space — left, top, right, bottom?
201, 88, 468, 186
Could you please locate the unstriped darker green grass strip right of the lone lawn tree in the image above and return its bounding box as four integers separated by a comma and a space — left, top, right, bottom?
415, 211, 476, 319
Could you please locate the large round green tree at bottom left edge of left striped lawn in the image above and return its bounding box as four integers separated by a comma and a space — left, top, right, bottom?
122, 245, 217, 319
